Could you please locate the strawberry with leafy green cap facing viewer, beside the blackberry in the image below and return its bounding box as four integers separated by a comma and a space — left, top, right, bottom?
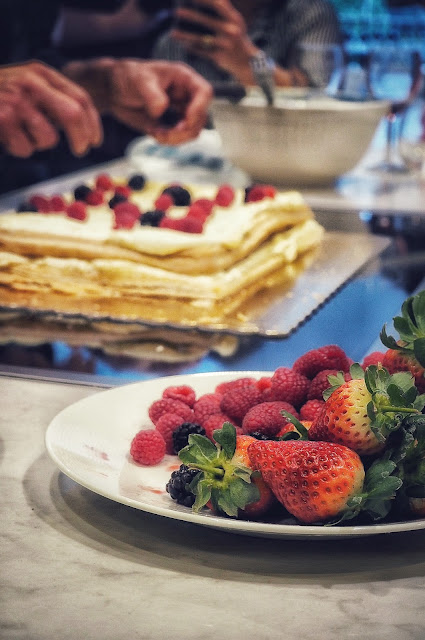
178, 422, 274, 518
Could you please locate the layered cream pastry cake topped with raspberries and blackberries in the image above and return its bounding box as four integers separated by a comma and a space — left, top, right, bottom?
0, 174, 323, 326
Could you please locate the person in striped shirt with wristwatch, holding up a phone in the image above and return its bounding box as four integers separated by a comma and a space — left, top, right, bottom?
153, 0, 342, 87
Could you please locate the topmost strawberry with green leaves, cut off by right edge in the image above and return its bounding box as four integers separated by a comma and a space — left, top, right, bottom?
380, 291, 425, 393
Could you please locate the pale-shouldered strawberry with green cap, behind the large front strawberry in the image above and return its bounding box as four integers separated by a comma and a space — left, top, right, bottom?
309, 365, 424, 455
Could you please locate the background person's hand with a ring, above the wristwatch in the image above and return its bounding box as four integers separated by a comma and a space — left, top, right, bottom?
171, 0, 259, 84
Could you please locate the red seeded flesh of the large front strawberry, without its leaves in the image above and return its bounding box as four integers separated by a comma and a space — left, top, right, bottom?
248, 440, 365, 523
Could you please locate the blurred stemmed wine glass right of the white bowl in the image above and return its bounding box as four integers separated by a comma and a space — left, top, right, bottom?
368, 44, 421, 173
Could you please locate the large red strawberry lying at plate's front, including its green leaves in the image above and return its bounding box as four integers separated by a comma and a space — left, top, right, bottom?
248, 440, 401, 524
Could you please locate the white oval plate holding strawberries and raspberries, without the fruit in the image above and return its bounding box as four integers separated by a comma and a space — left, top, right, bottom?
46, 371, 425, 539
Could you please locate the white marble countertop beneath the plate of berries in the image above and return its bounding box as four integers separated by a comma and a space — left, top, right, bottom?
0, 377, 425, 640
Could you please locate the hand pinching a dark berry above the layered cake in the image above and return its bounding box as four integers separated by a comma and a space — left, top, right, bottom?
67, 58, 212, 144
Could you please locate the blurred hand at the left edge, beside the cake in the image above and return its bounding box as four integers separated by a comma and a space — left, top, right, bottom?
0, 61, 102, 158
